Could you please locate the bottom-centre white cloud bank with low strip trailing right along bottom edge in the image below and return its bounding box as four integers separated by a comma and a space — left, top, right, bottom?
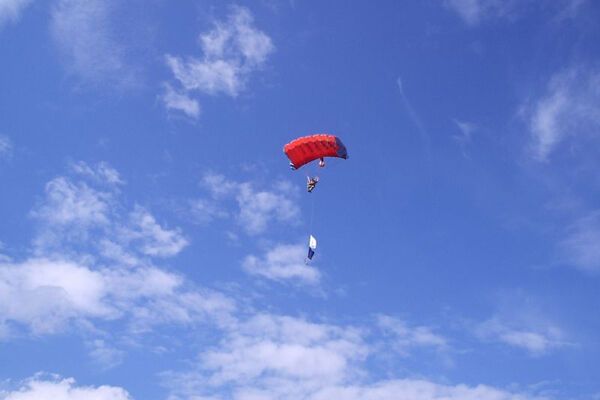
163, 314, 542, 400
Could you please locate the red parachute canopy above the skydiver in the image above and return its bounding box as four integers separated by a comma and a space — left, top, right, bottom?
283, 134, 348, 169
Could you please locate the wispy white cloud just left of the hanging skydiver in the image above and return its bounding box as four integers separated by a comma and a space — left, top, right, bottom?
197, 173, 300, 235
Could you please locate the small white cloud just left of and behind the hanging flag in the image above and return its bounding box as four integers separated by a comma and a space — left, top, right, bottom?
242, 245, 321, 285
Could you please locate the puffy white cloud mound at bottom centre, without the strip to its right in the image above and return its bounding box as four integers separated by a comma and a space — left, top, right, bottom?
167, 314, 367, 399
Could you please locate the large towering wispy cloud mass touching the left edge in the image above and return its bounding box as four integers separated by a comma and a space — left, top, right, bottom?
0, 163, 235, 354
